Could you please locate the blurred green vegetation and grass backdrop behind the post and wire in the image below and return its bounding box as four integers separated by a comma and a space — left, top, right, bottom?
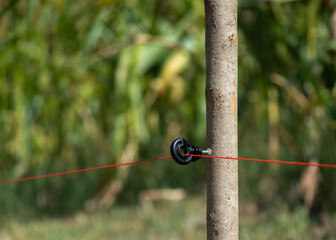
0, 0, 336, 240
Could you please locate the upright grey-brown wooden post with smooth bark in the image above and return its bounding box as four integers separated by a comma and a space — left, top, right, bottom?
205, 0, 238, 240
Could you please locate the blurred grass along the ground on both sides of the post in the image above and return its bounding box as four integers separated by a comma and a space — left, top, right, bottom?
0, 195, 336, 240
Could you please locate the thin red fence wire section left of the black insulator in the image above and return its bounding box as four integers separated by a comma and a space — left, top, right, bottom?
0, 156, 171, 185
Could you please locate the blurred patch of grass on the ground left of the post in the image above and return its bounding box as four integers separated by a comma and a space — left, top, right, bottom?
0, 195, 205, 240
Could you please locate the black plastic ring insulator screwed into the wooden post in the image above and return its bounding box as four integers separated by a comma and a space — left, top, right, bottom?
170, 138, 202, 165
